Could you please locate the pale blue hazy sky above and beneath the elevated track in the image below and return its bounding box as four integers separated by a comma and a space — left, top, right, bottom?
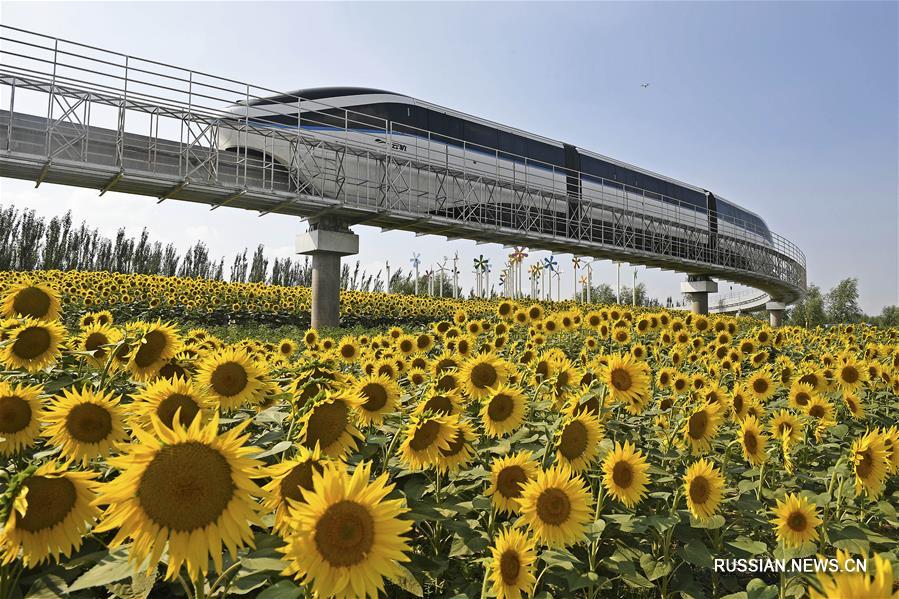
0, 2, 899, 312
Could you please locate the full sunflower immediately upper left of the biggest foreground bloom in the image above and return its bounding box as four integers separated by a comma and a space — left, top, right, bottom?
41, 387, 128, 465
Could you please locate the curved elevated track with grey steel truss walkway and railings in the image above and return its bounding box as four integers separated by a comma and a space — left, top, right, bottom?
0, 26, 806, 312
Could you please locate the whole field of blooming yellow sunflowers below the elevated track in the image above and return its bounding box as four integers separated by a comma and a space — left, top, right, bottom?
0, 272, 899, 599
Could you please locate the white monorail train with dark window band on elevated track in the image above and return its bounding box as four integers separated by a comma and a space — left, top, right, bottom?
217, 87, 772, 250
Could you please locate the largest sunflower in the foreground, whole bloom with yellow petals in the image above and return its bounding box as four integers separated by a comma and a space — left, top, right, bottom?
96, 414, 264, 580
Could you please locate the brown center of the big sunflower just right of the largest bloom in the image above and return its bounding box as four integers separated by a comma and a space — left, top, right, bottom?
315, 499, 375, 568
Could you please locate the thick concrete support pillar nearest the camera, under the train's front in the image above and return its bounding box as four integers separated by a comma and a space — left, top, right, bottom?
296, 223, 359, 329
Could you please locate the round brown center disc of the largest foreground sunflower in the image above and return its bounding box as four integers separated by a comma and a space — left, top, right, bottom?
137, 441, 234, 532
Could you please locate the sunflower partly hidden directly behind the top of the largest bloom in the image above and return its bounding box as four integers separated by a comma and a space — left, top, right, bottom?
131, 377, 211, 430
